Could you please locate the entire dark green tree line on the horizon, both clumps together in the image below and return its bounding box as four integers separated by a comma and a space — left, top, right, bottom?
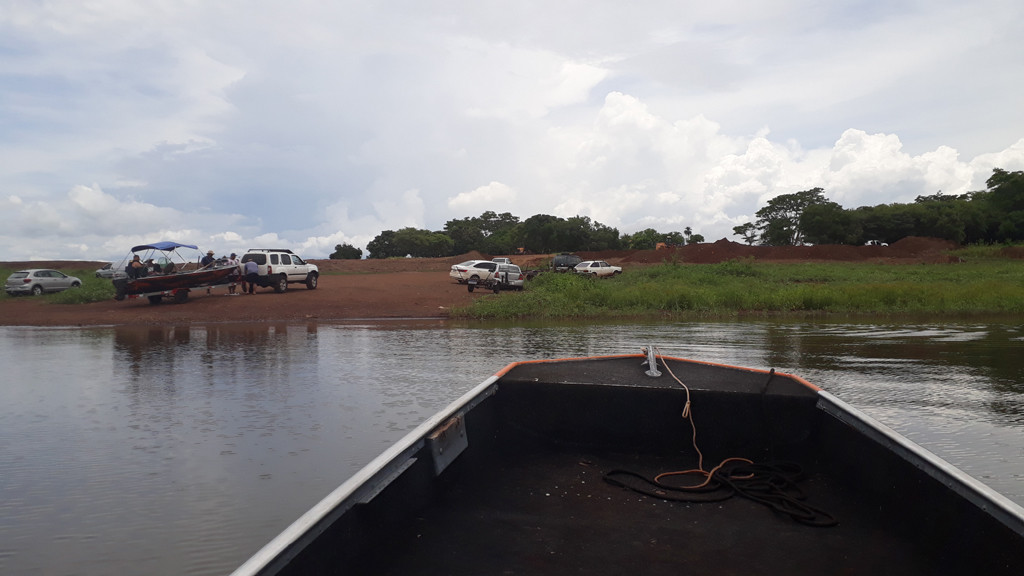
330, 168, 1024, 258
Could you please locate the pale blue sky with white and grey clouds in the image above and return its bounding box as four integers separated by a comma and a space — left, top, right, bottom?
0, 0, 1024, 261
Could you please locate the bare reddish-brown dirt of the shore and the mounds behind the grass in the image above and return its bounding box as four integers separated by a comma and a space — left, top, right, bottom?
0, 238, 978, 326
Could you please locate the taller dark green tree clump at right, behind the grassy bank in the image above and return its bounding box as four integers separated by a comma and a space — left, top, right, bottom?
732, 168, 1024, 246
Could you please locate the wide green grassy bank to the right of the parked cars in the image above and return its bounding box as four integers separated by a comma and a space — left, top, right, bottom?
452, 249, 1024, 319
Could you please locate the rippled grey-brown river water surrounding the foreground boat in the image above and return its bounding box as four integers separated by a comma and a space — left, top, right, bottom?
0, 321, 1024, 575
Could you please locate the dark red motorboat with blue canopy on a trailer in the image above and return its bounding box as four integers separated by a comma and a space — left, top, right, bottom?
112, 242, 241, 304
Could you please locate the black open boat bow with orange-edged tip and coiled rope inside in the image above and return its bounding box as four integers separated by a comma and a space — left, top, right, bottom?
233, 347, 1024, 576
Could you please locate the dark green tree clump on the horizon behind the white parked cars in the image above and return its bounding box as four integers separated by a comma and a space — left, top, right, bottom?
330, 210, 705, 259
